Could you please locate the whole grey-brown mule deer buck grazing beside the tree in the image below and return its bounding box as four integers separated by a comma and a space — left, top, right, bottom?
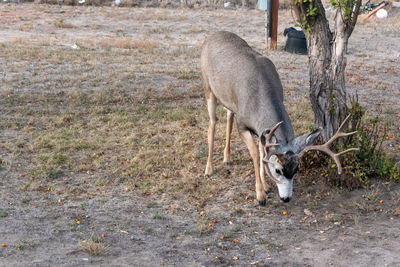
201, 31, 356, 206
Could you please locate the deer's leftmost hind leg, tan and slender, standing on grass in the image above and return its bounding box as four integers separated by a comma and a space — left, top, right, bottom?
205, 91, 217, 177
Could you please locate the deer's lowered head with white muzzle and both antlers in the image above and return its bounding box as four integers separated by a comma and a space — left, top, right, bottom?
260, 116, 358, 202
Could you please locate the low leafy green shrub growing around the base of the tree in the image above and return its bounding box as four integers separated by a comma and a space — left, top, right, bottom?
302, 97, 400, 189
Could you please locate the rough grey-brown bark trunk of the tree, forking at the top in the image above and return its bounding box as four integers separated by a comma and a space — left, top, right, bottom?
292, 0, 361, 141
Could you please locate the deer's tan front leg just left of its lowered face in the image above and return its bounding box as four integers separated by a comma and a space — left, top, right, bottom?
240, 131, 266, 206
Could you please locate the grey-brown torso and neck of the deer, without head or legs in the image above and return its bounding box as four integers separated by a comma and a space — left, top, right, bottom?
201, 31, 294, 143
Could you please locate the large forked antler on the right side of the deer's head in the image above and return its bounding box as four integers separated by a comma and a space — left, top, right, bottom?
298, 115, 359, 174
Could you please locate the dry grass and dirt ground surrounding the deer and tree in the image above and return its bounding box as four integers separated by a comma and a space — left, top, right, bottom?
0, 4, 400, 266
